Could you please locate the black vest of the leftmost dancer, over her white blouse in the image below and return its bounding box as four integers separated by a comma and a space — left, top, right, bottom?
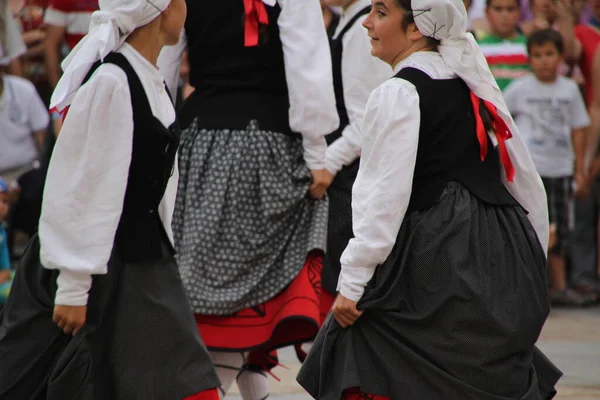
84, 53, 180, 262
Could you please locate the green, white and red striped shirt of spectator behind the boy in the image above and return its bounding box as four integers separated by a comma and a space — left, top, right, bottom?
478, 34, 530, 90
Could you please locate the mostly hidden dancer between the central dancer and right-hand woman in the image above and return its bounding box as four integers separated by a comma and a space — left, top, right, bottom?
321, 0, 392, 317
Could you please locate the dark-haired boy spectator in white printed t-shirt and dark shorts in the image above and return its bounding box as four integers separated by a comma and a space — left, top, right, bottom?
504, 29, 590, 305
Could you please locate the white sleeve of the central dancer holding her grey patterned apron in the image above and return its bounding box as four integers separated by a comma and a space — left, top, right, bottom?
277, 0, 340, 169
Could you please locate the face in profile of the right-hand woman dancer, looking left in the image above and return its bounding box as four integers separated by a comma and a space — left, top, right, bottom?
363, 0, 425, 67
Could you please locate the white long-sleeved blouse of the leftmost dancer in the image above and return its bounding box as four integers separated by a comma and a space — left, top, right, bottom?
39, 44, 179, 306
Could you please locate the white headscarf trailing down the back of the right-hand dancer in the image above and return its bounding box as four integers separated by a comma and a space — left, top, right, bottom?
411, 0, 549, 250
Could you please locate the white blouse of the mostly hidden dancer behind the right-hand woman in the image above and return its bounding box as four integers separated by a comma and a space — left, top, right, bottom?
326, 0, 392, 174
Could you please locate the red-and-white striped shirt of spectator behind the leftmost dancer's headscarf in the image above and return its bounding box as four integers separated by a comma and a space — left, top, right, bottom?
44, 0, 98, 49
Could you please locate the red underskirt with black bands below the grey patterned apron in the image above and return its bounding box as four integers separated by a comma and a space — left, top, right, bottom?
196, 251, 323, 351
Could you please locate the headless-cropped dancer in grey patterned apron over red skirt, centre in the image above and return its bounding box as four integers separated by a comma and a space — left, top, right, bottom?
161, 0, 339, 400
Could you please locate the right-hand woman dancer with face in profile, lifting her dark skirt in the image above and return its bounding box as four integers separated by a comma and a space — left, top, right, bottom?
298, 0, 555, 400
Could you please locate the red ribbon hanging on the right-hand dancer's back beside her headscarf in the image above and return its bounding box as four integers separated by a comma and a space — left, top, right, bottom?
471, 92, 515, 182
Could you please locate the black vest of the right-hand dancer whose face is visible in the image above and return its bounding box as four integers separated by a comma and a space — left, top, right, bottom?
396, 68, 518, 211
